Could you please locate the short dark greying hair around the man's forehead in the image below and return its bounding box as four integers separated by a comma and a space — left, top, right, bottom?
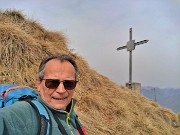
37, 54, 78, 81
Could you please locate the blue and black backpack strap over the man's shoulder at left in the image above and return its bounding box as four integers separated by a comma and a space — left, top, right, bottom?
25, 99, 52, 135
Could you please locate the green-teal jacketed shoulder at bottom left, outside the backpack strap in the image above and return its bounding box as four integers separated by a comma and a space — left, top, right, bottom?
0, 101, 37, 135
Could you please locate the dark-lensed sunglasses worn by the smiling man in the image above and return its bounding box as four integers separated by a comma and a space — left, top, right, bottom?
42, 79, 78, 90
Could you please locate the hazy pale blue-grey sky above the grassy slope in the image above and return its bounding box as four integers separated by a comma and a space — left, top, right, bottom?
0, 0, 180, 88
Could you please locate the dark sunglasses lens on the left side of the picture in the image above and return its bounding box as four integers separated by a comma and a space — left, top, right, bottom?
45, 79, 60, 89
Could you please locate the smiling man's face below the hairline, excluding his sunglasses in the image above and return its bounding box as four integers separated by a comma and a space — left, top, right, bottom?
37, 59, 75, 110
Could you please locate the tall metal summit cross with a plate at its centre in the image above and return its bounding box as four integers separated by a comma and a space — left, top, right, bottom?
117, 28, 149, 89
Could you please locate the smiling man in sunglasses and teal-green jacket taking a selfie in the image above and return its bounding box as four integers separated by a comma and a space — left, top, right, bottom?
0, 54, 86, 135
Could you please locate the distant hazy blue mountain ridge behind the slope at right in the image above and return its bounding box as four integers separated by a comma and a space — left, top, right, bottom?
141, 87, 180, 113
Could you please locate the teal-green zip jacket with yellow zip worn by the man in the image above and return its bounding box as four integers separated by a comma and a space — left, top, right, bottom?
0, 97, 86, 135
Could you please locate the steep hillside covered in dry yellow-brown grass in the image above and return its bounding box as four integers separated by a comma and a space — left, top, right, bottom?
0, 10, 180, 135
